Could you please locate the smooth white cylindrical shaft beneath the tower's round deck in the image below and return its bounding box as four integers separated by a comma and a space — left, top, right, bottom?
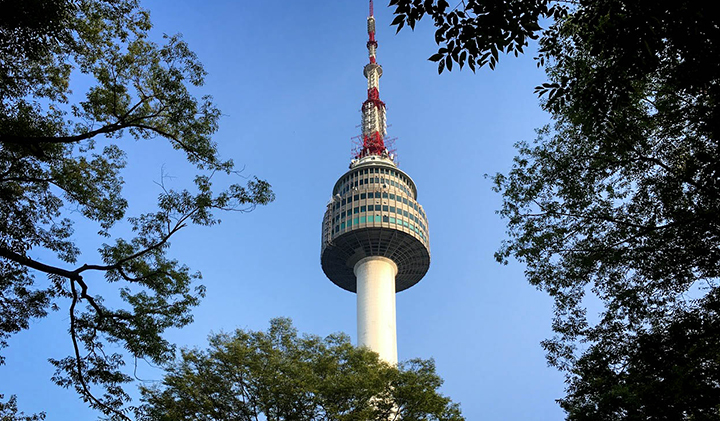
354, 256, 397, 365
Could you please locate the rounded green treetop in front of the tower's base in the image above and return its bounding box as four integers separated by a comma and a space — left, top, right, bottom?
138, 319, 464, 421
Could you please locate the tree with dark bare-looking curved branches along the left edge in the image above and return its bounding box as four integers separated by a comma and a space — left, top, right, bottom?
0, 0, 273, 419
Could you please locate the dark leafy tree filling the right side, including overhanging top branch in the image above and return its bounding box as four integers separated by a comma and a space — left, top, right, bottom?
394, 0, 720, 420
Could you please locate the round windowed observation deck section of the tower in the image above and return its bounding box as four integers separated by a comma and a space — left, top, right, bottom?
321, 155, 430, 292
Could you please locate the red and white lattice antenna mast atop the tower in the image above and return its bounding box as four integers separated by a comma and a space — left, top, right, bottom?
357, 0, 388, 158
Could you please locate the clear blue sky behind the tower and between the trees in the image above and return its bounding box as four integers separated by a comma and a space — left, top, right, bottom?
0, 0, 563, 421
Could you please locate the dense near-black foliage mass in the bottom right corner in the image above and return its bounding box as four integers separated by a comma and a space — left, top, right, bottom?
560, 291, 720, 420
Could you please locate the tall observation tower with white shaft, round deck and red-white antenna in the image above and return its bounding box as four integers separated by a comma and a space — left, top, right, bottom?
320, 0, 430, 364
